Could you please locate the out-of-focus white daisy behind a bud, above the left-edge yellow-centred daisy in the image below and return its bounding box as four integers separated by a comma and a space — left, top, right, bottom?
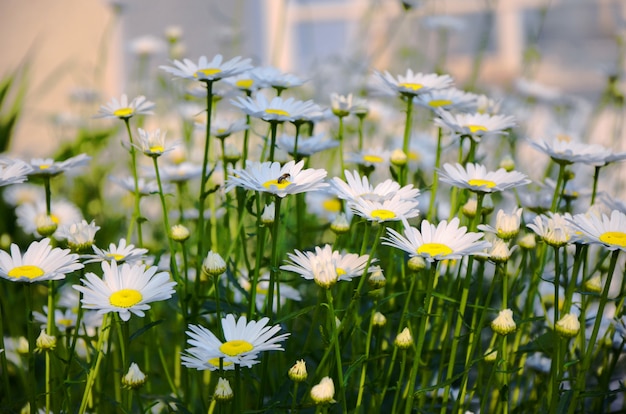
15, 199, 83, 236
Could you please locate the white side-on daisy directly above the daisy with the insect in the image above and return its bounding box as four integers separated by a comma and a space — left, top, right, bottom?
230, 94, 323, 122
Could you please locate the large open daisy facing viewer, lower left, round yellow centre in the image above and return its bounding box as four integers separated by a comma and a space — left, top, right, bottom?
73, 261, 176, 321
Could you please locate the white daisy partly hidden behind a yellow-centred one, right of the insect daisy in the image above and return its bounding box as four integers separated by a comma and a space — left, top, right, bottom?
330, 170, 420, 202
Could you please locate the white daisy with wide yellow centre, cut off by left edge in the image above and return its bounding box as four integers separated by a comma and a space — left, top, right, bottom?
0, 238, 84, 283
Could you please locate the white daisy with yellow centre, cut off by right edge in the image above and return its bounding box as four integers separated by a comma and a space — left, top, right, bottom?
566, 210, 626, 251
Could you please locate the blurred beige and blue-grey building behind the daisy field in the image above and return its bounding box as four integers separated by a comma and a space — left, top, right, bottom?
0, 0, 626, 156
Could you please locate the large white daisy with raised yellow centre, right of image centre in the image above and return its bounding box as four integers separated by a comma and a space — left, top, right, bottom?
383, 217, 491, 262
